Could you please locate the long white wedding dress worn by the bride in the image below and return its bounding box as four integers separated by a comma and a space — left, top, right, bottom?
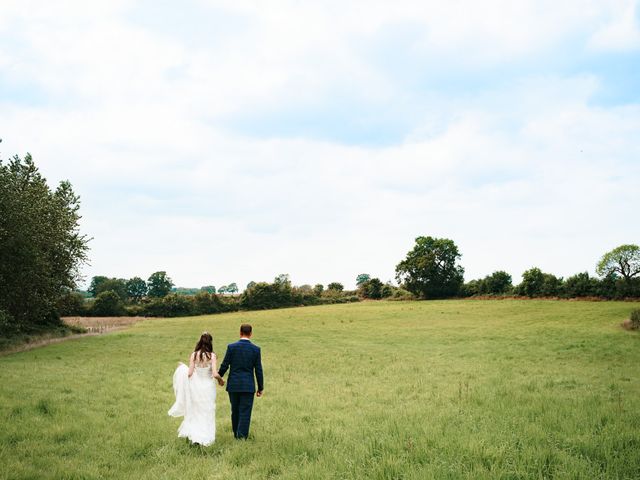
169, 363, 216, 447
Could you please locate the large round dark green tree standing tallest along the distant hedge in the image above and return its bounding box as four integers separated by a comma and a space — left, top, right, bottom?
396, 237, 464, 298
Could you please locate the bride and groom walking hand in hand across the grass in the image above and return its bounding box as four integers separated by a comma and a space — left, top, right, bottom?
169, 323, 264, 446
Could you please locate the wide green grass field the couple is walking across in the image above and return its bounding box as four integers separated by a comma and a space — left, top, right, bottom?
0, 300, 640, 480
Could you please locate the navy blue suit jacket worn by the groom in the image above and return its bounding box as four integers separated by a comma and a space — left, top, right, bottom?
218, 340, 264, 393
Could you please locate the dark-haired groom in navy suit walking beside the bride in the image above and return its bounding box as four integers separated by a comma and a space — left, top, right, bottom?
218, 323, 264, 438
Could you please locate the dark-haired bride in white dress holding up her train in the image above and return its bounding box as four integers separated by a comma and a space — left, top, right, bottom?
169, 332, 224, 447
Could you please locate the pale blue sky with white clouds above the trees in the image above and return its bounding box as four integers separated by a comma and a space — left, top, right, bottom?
0, 0, 640, 289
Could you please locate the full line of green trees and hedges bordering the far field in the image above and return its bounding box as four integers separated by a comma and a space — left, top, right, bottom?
0, 154, 640, 336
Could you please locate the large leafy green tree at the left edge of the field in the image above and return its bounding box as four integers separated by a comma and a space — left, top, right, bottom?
0, 154, 88, 331
